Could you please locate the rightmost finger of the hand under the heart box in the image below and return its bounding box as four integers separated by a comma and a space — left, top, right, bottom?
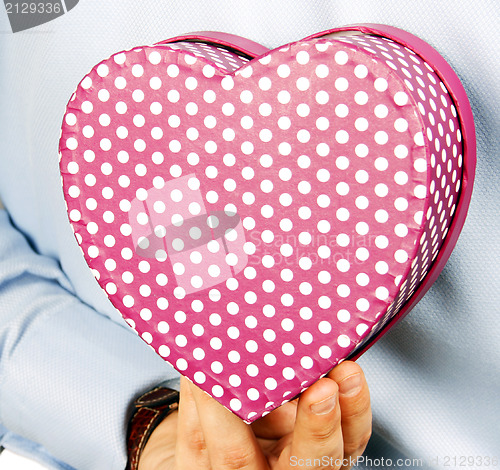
328, 361, 372, 469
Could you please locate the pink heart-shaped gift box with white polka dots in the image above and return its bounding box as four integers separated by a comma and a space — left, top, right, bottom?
60, 25, 475, 422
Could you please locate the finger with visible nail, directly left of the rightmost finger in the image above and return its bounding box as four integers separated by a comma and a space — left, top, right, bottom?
289, 377, 343, 470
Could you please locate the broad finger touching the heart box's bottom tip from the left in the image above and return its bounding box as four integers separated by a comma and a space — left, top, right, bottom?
189, 383, 268, 470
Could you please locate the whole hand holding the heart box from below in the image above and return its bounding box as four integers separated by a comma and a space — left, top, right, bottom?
139, 361, 372, 470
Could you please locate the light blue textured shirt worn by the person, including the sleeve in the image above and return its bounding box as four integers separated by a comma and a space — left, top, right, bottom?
0, 0, 500, 470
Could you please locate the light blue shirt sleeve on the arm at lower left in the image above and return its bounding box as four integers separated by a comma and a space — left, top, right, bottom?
0, 210, 178, 470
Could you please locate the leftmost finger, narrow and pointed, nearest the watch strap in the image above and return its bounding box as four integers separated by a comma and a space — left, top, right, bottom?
175, 377, 211, 470
